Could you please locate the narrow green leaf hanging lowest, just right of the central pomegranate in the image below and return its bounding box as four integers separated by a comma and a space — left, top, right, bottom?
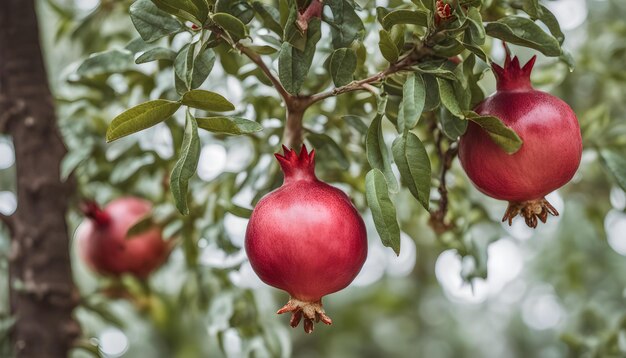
365, 168, 400, 255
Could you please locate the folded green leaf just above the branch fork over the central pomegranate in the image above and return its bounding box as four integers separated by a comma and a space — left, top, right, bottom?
278, 18, 321, 94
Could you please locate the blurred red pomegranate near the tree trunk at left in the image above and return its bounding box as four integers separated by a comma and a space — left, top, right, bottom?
77, 197, 171, 279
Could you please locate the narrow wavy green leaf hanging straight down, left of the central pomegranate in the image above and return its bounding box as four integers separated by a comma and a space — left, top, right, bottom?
170, 111, 200, 215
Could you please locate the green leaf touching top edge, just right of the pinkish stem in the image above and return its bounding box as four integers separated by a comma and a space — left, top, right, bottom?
324, 0, 365, 49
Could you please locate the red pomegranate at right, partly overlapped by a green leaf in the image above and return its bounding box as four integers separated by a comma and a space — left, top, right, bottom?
459, 51, 582, 228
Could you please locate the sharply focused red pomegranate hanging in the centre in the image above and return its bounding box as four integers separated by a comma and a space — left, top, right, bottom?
245, 145, 367, 333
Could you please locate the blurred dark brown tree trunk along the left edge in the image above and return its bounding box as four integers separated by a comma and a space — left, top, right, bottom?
0, 0, 80, 358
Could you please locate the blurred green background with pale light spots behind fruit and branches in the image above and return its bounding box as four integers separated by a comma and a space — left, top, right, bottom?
0, 0, 626, 358
